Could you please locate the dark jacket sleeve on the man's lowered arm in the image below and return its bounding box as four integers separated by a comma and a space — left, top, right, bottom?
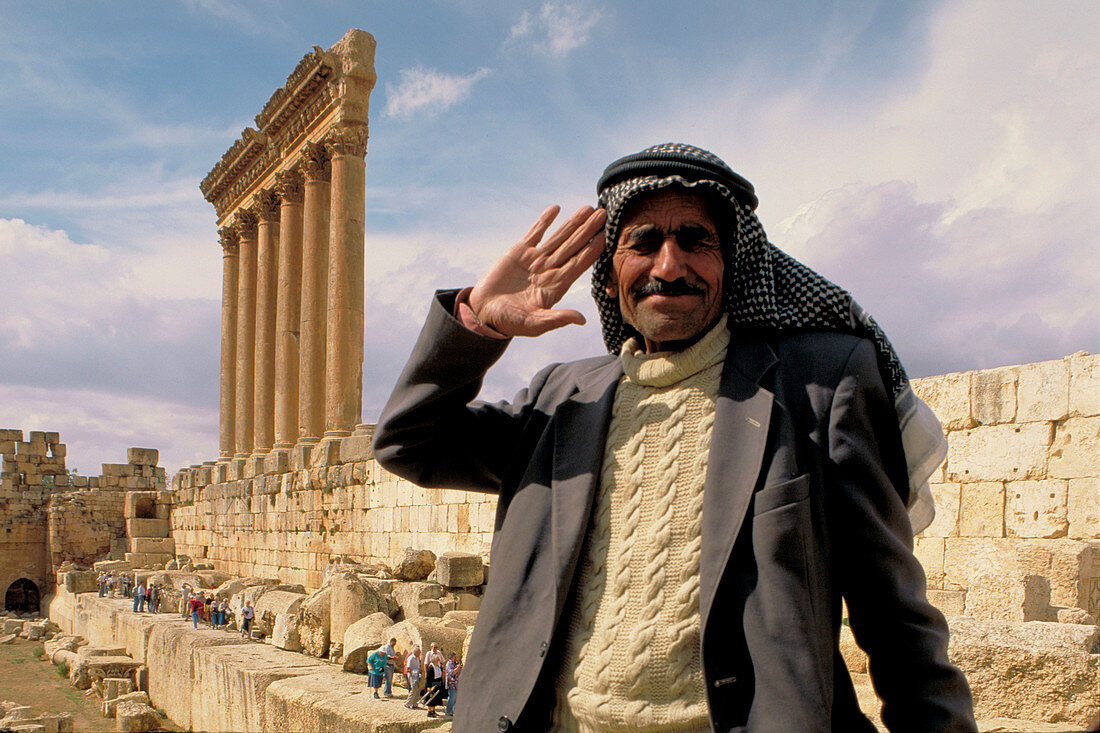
828, 340, 977, 732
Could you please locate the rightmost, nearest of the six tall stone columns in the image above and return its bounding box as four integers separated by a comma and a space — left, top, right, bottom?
325, 125, 366, 438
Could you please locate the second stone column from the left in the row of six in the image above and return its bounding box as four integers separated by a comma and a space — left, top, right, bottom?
233, 209, 256, 458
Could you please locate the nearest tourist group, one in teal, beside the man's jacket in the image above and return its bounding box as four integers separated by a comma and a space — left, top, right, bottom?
366, 638, 462, 718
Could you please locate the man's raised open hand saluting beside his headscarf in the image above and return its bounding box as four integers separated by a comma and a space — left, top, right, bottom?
470, 201, 607, 336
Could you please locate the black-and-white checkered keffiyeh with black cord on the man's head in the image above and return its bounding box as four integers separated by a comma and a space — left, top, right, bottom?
592, 143, 946, 532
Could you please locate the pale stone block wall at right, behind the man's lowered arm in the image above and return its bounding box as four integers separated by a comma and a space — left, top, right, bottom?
913, 352, 1100, 621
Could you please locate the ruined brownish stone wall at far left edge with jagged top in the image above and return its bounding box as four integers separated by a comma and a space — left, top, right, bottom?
0, 429, 166, 594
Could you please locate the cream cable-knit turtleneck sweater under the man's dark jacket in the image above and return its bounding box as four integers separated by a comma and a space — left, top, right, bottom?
554, 318, 729, 733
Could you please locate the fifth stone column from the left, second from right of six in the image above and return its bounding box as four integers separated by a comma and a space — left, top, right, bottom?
298, 143, 331, 445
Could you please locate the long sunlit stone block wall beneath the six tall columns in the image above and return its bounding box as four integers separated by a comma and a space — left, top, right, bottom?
172, 434, 496, 588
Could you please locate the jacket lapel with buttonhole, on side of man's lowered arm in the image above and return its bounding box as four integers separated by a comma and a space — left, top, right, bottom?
699, 331, 777, 630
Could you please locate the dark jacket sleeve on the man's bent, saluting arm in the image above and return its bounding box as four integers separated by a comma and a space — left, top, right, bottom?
374, 291, 553, 492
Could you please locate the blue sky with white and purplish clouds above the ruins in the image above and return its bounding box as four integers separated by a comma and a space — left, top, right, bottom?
0, 0, 1100, 475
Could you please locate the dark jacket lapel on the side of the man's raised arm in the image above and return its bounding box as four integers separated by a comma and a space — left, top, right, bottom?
550, 359, 623, 609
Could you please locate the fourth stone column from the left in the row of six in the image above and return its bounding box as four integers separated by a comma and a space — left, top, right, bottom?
275, 169, 303, 450
